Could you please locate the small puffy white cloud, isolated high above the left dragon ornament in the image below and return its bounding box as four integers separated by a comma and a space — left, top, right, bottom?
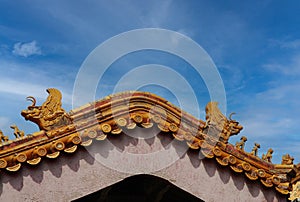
12, 41, 42, 57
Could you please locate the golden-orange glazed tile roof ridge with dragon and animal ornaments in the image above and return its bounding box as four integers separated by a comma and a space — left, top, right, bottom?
0, 88, 300, 199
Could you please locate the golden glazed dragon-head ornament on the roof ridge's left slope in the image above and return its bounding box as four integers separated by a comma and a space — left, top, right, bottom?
21, 88, 71, 131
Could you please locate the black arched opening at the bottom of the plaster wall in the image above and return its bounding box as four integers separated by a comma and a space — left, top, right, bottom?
74, 174, 203, 202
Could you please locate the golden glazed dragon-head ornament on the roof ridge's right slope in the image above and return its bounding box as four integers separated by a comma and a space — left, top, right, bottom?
205, 102, 243, 143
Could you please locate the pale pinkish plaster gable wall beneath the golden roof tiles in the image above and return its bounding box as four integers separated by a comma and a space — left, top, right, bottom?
0, 129, 286, 201
